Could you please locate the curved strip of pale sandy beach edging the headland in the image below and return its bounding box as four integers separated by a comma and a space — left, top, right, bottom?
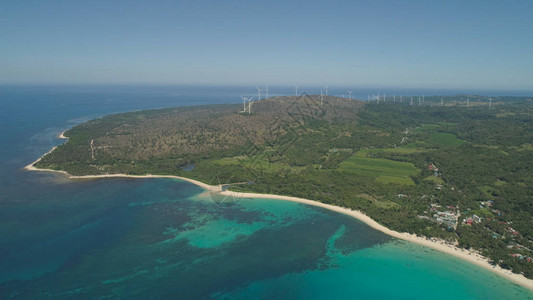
24, 136, 533, 290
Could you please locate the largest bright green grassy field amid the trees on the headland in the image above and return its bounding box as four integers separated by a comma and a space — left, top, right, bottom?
340, 156, 419, 185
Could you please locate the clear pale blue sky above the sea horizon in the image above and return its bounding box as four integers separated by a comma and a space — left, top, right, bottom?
0, 0, 533, 90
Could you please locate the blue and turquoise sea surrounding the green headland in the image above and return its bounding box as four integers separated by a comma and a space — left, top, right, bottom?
0, 86, 533, 299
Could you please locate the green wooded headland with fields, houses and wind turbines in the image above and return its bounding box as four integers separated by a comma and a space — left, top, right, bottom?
37, 96, 533, 278
